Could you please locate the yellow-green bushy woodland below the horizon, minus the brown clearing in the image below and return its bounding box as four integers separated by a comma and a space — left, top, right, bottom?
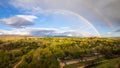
0, 36, 120, 68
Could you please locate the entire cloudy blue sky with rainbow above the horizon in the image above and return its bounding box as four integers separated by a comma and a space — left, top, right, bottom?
0, 0, 120, 37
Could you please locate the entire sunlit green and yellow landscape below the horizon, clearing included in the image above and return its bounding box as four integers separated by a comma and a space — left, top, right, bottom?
0, 36, 120, 68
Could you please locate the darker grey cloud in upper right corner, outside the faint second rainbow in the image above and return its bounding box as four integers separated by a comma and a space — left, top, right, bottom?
95, 0, 120, 27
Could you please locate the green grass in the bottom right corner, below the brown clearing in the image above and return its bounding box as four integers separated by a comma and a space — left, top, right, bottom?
64, 58, 120, 68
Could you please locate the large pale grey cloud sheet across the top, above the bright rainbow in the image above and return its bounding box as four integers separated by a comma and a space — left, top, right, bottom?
9, 0, 120, 28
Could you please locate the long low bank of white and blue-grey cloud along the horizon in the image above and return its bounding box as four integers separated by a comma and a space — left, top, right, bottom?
0, 28, 95, 37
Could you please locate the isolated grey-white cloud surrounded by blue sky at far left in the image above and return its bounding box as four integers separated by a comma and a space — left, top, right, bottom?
0, 15, 37, 28
